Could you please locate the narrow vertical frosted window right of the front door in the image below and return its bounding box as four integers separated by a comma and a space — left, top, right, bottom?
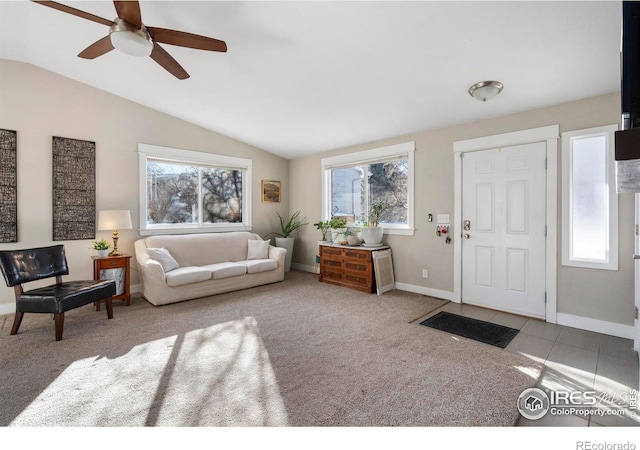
562, 125, 618, 270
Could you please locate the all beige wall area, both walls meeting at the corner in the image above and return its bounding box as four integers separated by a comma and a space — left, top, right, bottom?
0, 60, 634, 325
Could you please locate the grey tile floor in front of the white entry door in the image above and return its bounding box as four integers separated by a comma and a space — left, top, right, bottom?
416, 303, 640, 427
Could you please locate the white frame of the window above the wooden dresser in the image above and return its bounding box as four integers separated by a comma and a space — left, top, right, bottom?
320, 141, 415, 236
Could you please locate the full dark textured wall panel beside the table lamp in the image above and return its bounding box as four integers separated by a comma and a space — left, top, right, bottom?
53, 136, 96, 241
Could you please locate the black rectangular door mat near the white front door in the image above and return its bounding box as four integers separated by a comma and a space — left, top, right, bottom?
420, 311, 520, 348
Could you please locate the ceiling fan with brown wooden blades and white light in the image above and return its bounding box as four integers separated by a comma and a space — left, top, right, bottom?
33, 0, 227, 80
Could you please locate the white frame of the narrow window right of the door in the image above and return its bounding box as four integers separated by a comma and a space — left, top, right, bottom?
562, 125, 618, 270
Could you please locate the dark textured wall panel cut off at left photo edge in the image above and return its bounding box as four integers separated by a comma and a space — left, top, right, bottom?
0, 129, 18, 243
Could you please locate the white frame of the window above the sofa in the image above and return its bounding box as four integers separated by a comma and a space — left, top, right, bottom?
138, 144, 253, 236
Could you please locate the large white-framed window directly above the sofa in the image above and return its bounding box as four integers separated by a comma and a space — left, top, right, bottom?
138, 144, 251, 234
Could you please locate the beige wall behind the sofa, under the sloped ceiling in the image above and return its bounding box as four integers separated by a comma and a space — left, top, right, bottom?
0, 60, 289, 313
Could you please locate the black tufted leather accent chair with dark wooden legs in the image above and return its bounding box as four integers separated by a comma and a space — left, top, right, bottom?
0, 245, 116, 341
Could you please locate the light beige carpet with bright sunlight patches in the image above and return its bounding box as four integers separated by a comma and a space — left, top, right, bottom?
0, 271, 541, 427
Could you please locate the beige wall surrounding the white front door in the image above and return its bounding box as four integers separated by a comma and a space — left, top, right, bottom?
290, 93, 634, 325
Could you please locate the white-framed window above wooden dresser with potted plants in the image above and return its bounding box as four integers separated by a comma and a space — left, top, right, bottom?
322, 142, 415, 234
